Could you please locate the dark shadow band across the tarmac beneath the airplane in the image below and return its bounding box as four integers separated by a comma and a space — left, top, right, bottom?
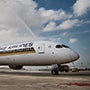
0, 70, 90, 77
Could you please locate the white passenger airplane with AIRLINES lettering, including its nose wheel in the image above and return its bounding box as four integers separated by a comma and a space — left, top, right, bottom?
0, 40, 80, 75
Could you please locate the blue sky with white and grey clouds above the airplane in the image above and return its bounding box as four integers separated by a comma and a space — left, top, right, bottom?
0, 0, 90, 67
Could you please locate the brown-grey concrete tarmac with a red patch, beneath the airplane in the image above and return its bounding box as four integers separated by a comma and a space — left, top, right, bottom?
0, 69, 90, 90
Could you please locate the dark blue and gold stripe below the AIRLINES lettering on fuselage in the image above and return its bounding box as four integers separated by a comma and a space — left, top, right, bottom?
0, 47, 36, 56
